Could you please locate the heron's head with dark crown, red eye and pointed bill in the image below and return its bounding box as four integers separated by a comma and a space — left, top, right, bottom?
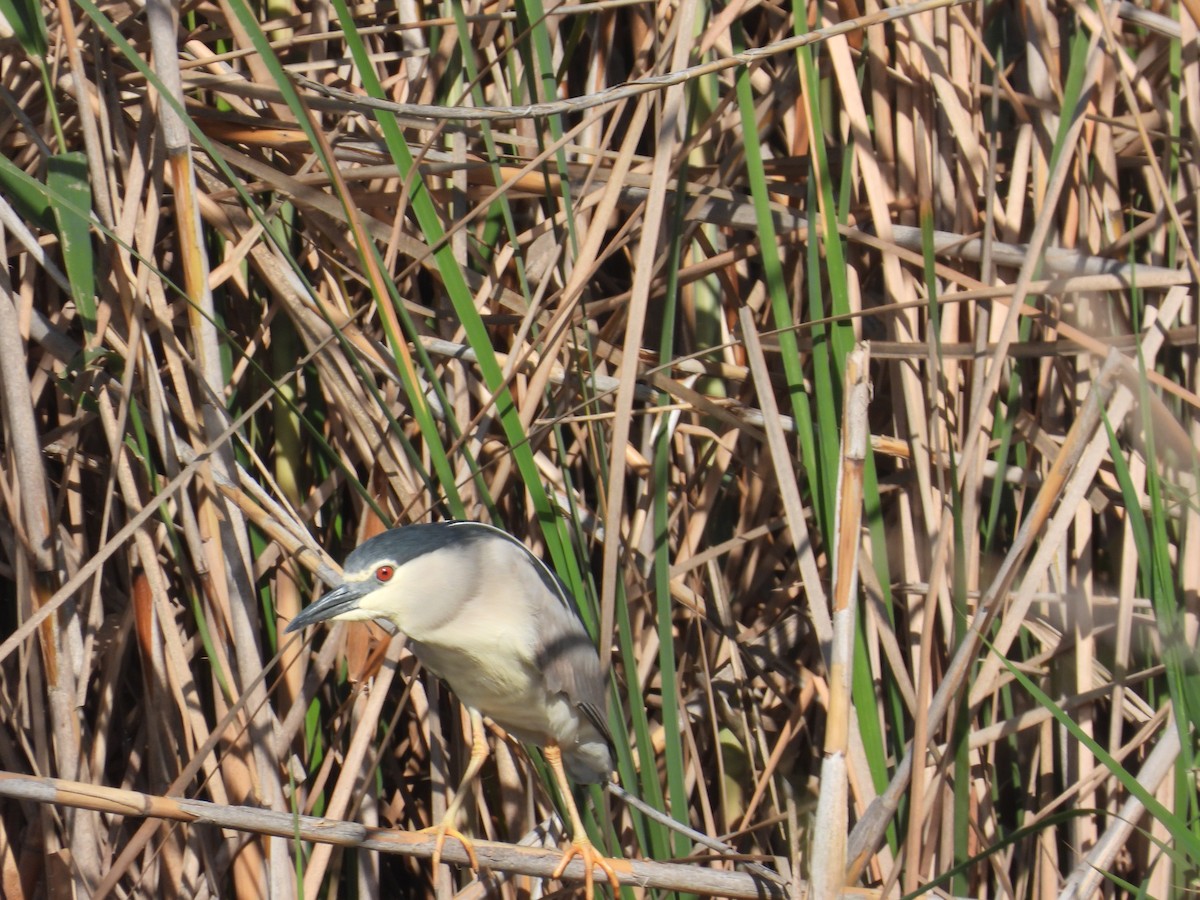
287, 522, 476, 640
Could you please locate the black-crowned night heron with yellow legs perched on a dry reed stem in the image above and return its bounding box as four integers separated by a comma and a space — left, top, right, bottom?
288, 522, 619, 895
